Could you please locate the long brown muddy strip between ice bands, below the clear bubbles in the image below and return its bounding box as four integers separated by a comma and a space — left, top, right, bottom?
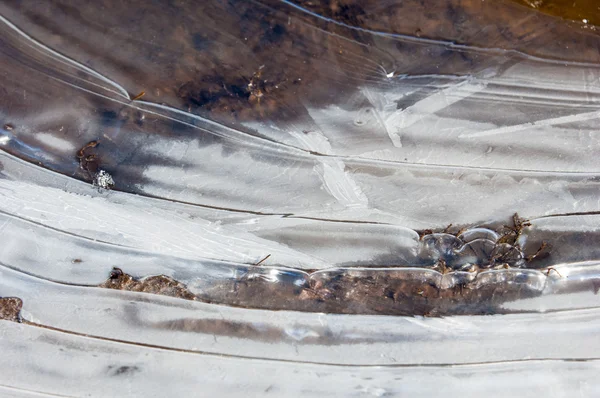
99, 266, 541, 317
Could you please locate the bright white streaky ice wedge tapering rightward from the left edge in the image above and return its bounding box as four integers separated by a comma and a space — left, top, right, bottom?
0, 180, 328, 268
